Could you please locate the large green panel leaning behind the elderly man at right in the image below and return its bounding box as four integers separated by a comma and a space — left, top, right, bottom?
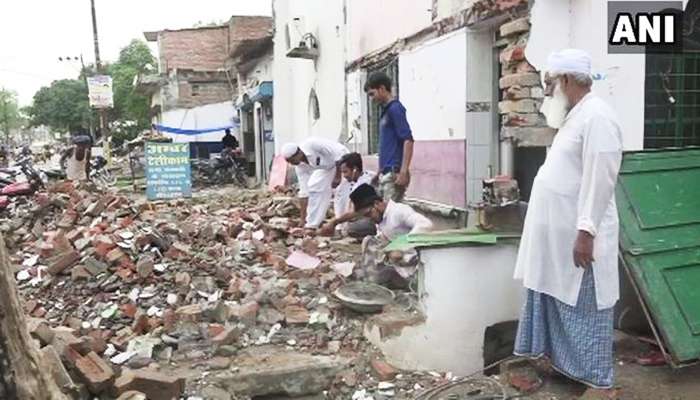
616, 148, 700, 366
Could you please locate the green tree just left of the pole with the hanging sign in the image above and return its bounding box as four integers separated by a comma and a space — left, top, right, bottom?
30, 79, 91, 132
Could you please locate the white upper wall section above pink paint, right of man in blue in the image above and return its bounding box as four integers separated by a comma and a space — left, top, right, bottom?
399, 29, 467, 140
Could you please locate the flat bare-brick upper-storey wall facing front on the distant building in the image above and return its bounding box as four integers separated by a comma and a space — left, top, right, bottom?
159, 26, 229, 72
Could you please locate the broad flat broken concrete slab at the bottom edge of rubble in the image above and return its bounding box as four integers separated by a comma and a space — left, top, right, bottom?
210, 346, 351, 397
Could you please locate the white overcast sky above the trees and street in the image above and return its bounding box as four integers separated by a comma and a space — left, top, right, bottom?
0, 0, 272, 105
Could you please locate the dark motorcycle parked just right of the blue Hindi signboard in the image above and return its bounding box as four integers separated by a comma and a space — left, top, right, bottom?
192, 150, 248, 187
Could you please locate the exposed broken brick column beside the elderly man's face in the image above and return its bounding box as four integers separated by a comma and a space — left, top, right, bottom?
498, 17, 555, 147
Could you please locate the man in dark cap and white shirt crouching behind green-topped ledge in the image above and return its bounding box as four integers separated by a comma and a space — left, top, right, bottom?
350, 183, 433, 241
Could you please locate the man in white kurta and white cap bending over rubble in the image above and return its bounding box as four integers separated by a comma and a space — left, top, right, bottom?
282, 137, 349, 229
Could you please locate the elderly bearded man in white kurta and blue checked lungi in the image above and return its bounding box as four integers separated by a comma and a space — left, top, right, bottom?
515, 49, 622, 399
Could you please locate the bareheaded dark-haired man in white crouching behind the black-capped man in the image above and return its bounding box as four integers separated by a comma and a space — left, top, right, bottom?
320, 153, 376, 237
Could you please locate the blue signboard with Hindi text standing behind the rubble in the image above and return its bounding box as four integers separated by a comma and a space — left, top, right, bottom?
146, 142, 192, 200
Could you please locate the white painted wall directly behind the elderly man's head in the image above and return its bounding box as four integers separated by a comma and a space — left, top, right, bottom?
525, 0, 687, 150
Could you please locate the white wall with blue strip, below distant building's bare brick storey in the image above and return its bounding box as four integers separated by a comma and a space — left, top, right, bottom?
161, 101, 240, 143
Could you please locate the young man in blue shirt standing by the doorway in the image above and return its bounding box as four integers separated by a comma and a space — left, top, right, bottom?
365, 72, 413, 201
